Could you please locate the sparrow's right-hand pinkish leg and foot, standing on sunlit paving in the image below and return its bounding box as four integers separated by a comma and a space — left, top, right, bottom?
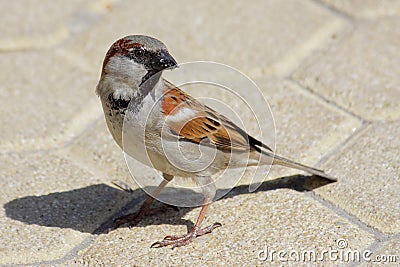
151, 198, 221, 248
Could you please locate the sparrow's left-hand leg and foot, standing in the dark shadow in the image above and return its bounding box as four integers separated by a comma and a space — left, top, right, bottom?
114, 173, 174, 228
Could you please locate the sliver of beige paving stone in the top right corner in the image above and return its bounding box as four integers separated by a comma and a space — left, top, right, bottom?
323, 0, 400, 18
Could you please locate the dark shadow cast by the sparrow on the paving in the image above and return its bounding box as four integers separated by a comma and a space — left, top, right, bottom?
4, 175, 331, 234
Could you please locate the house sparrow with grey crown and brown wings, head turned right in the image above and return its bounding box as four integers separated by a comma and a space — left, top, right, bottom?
96, 35, 336, 247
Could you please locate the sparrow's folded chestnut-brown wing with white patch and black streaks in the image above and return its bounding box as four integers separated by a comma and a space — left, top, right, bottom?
162, 82, 272, 152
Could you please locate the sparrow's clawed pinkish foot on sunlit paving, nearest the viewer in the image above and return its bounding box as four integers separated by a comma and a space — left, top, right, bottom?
151, 222, 222, 249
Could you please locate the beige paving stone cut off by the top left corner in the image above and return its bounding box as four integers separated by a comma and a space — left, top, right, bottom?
0, 0, 108, 51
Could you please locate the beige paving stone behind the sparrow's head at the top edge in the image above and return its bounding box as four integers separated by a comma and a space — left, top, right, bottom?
60, 0, 342, 76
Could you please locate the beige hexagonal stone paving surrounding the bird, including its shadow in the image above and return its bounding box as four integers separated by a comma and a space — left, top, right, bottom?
0, 0, 400, 266
